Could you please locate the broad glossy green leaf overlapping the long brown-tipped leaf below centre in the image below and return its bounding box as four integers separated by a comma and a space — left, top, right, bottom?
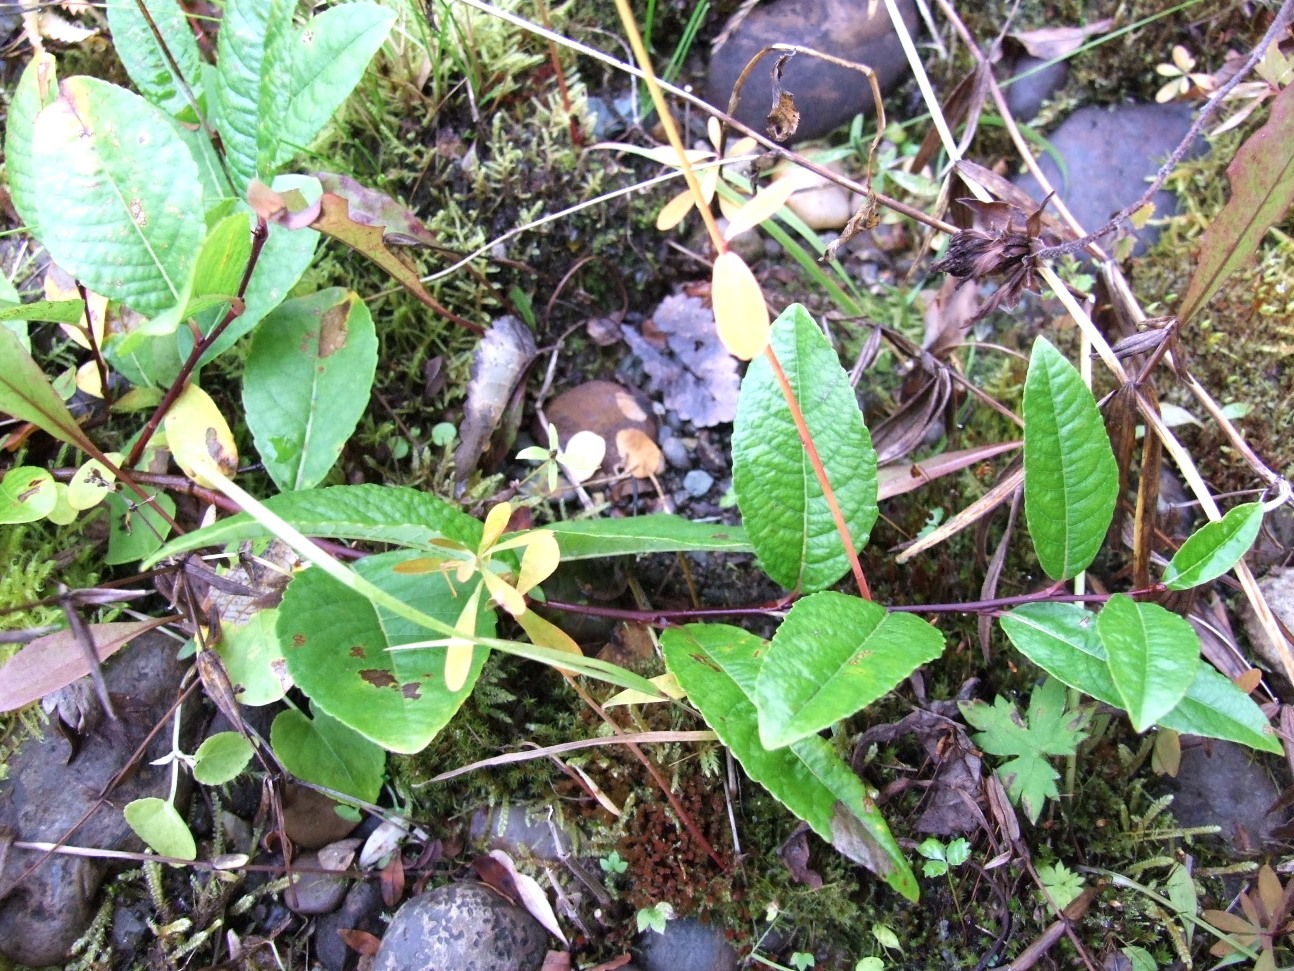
754, 590, 943, 748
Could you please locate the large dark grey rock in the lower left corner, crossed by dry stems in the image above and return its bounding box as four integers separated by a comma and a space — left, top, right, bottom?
0, 633, 201, 965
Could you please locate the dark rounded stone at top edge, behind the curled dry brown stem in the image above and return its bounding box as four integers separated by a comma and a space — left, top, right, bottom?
705, 0, 916, 141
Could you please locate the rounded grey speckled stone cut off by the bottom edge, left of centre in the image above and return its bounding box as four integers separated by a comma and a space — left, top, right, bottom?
373, 883, 547, 971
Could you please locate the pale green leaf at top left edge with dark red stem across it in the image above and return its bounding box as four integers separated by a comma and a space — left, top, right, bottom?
107, 0, 202, 115
